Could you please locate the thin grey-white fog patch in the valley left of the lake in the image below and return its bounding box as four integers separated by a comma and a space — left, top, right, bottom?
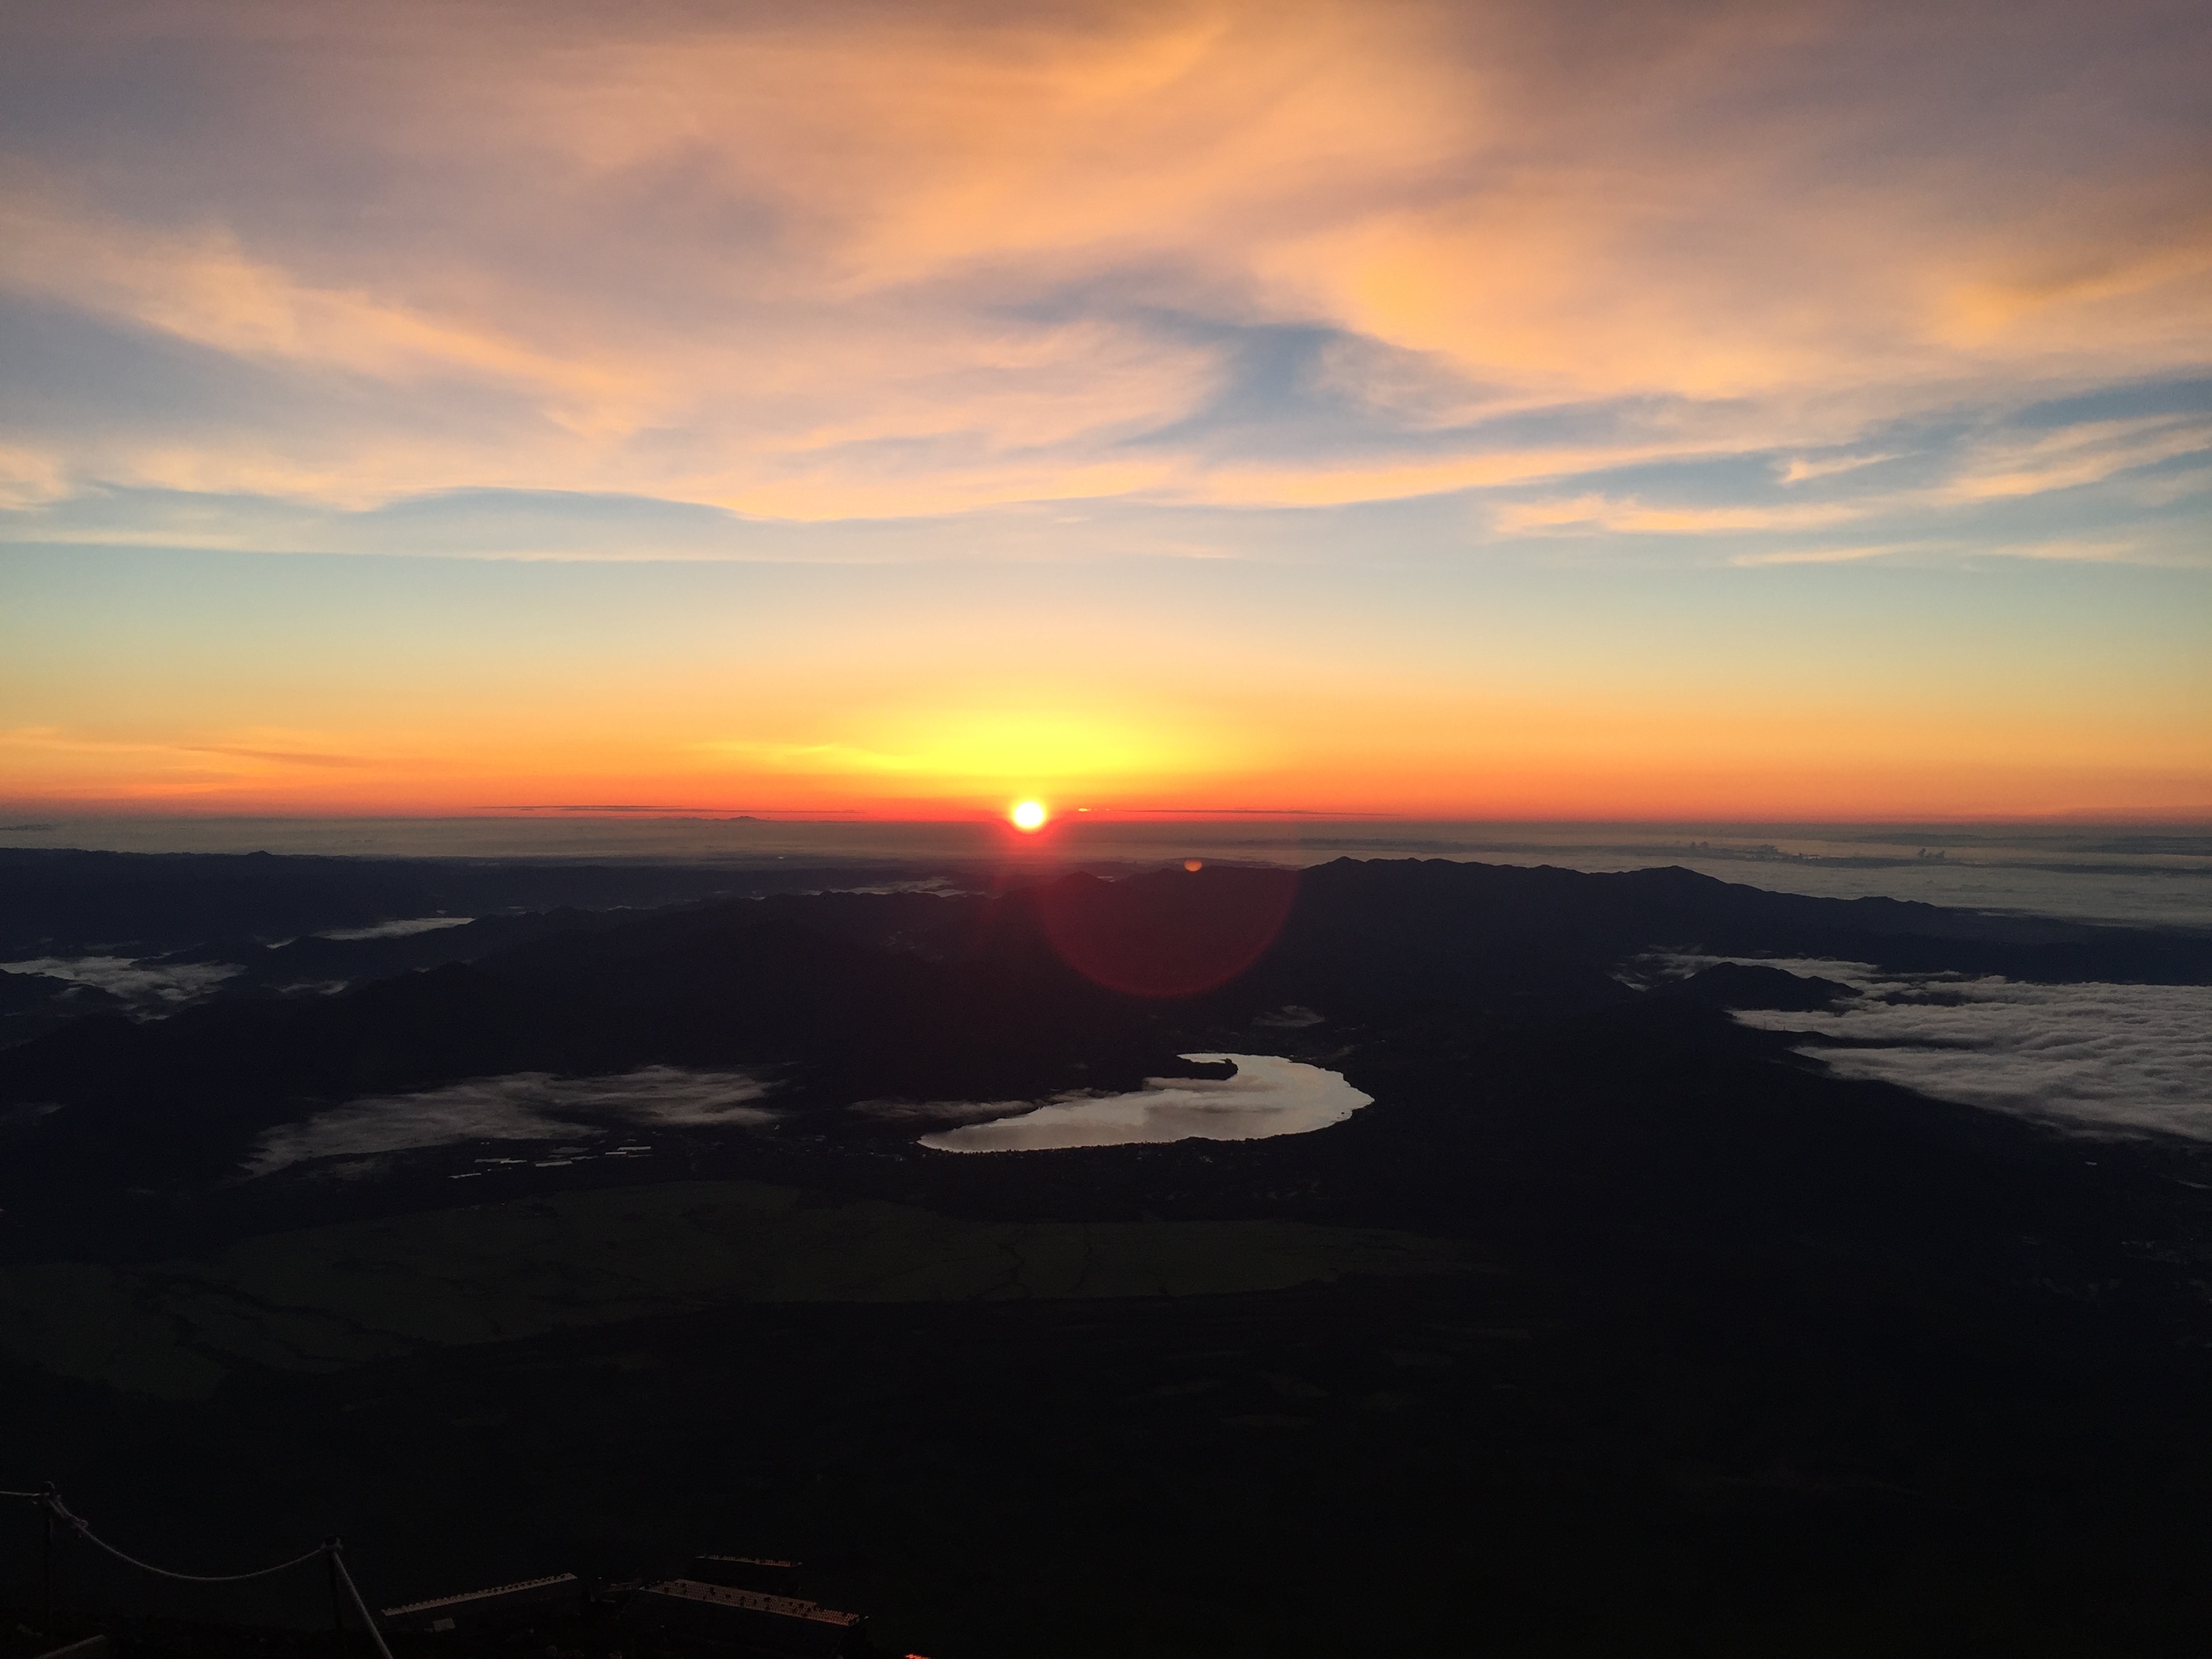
245, 1066, 774, 1174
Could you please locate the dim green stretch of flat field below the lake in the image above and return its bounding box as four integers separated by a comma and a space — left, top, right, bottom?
0, 1181, 1471, 1400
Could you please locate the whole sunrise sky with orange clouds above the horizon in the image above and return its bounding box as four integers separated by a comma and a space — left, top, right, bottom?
0, 0, 2212, 821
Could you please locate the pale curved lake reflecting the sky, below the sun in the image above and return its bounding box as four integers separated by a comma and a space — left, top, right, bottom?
920, 1055, 1374, 1153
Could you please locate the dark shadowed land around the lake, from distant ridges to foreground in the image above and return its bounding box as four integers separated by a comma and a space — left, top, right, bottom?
0, 854, 2212, 1659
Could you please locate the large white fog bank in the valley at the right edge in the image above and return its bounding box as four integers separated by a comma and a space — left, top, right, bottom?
1696, 958, 2212, 1139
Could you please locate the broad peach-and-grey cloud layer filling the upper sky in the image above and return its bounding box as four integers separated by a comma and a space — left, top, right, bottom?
0, 0, 2212, 533
